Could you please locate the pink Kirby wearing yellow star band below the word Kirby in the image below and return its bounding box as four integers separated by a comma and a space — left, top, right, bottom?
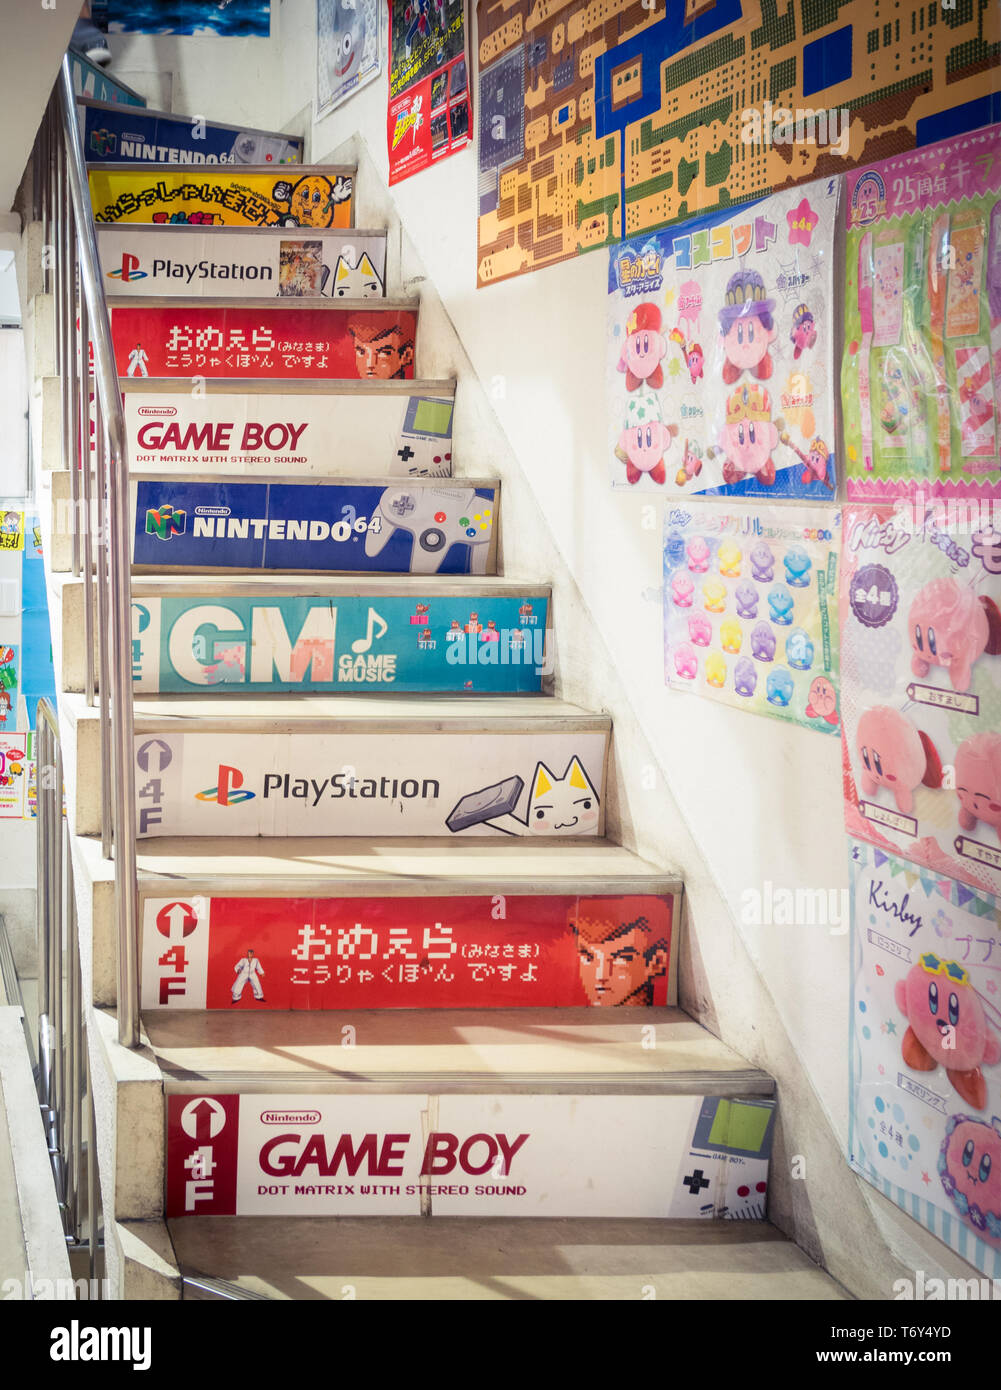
894, 951, 1001, 1111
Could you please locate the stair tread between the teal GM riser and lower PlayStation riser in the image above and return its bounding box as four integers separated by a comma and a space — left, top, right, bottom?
63, 691, 612, 734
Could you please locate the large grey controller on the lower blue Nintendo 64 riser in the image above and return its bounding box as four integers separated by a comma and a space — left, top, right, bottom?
366, 487, 496, 574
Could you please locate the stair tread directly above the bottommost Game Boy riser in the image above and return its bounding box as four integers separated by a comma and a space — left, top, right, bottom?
143, 1008, 774, 1094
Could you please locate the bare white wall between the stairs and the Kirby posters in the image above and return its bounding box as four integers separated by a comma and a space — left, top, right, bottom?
113, 0, 995, 1297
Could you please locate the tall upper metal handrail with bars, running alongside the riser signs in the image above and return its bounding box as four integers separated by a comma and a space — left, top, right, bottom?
49, 57, 139, 1048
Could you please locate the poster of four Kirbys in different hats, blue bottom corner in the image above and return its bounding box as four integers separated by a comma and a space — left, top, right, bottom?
605, 179, 840, 502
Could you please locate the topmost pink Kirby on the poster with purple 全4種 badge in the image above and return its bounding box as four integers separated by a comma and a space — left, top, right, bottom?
908, 578, 1001, 691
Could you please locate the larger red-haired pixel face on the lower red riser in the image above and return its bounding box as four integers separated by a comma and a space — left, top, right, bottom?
571, 898, 670, 1008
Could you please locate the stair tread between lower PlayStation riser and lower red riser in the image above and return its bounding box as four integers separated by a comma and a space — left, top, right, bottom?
125, 835, 681, 895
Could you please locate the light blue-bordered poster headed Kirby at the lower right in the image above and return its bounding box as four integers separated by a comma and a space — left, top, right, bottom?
848, 844, 1001, 1273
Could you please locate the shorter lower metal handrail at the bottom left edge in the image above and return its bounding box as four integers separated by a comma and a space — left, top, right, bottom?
35, 699, 101, 1289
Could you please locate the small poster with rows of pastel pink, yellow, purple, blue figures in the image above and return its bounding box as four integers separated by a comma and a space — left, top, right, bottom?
663, 503, 841, 734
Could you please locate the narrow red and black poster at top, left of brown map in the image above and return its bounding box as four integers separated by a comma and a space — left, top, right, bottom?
386, 0, 471, 183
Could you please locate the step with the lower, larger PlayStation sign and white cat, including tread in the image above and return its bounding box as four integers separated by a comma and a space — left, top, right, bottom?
61, 694, 610, 840
